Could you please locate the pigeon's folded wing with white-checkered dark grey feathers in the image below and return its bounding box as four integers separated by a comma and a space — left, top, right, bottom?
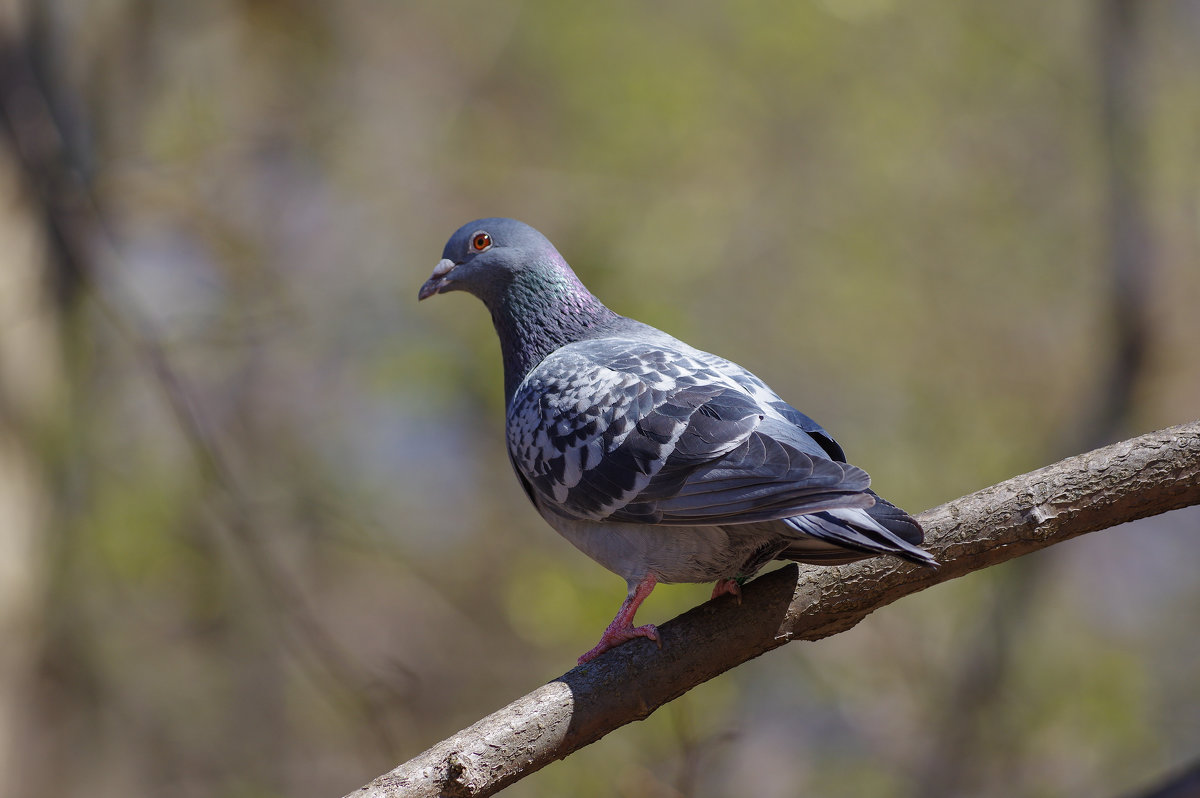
508, 338, 872, 526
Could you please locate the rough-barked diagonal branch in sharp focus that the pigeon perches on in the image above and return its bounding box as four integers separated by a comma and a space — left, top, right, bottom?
347, 421, 1200, 798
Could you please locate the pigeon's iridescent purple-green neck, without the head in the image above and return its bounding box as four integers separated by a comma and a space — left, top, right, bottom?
491, 250, 620, 404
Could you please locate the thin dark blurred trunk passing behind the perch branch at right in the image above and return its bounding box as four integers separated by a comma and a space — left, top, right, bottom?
910, 0, 1154, 798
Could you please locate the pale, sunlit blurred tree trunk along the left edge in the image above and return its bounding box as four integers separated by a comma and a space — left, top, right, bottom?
0, 2, 71, 796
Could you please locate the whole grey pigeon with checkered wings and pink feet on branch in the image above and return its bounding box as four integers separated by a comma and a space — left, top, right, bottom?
418, 218, 937, 664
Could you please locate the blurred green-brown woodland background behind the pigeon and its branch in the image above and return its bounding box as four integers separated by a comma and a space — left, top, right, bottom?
0, 0, 1200, 798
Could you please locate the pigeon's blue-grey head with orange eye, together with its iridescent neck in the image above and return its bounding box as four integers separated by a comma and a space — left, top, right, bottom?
416, 218, 622, 398
